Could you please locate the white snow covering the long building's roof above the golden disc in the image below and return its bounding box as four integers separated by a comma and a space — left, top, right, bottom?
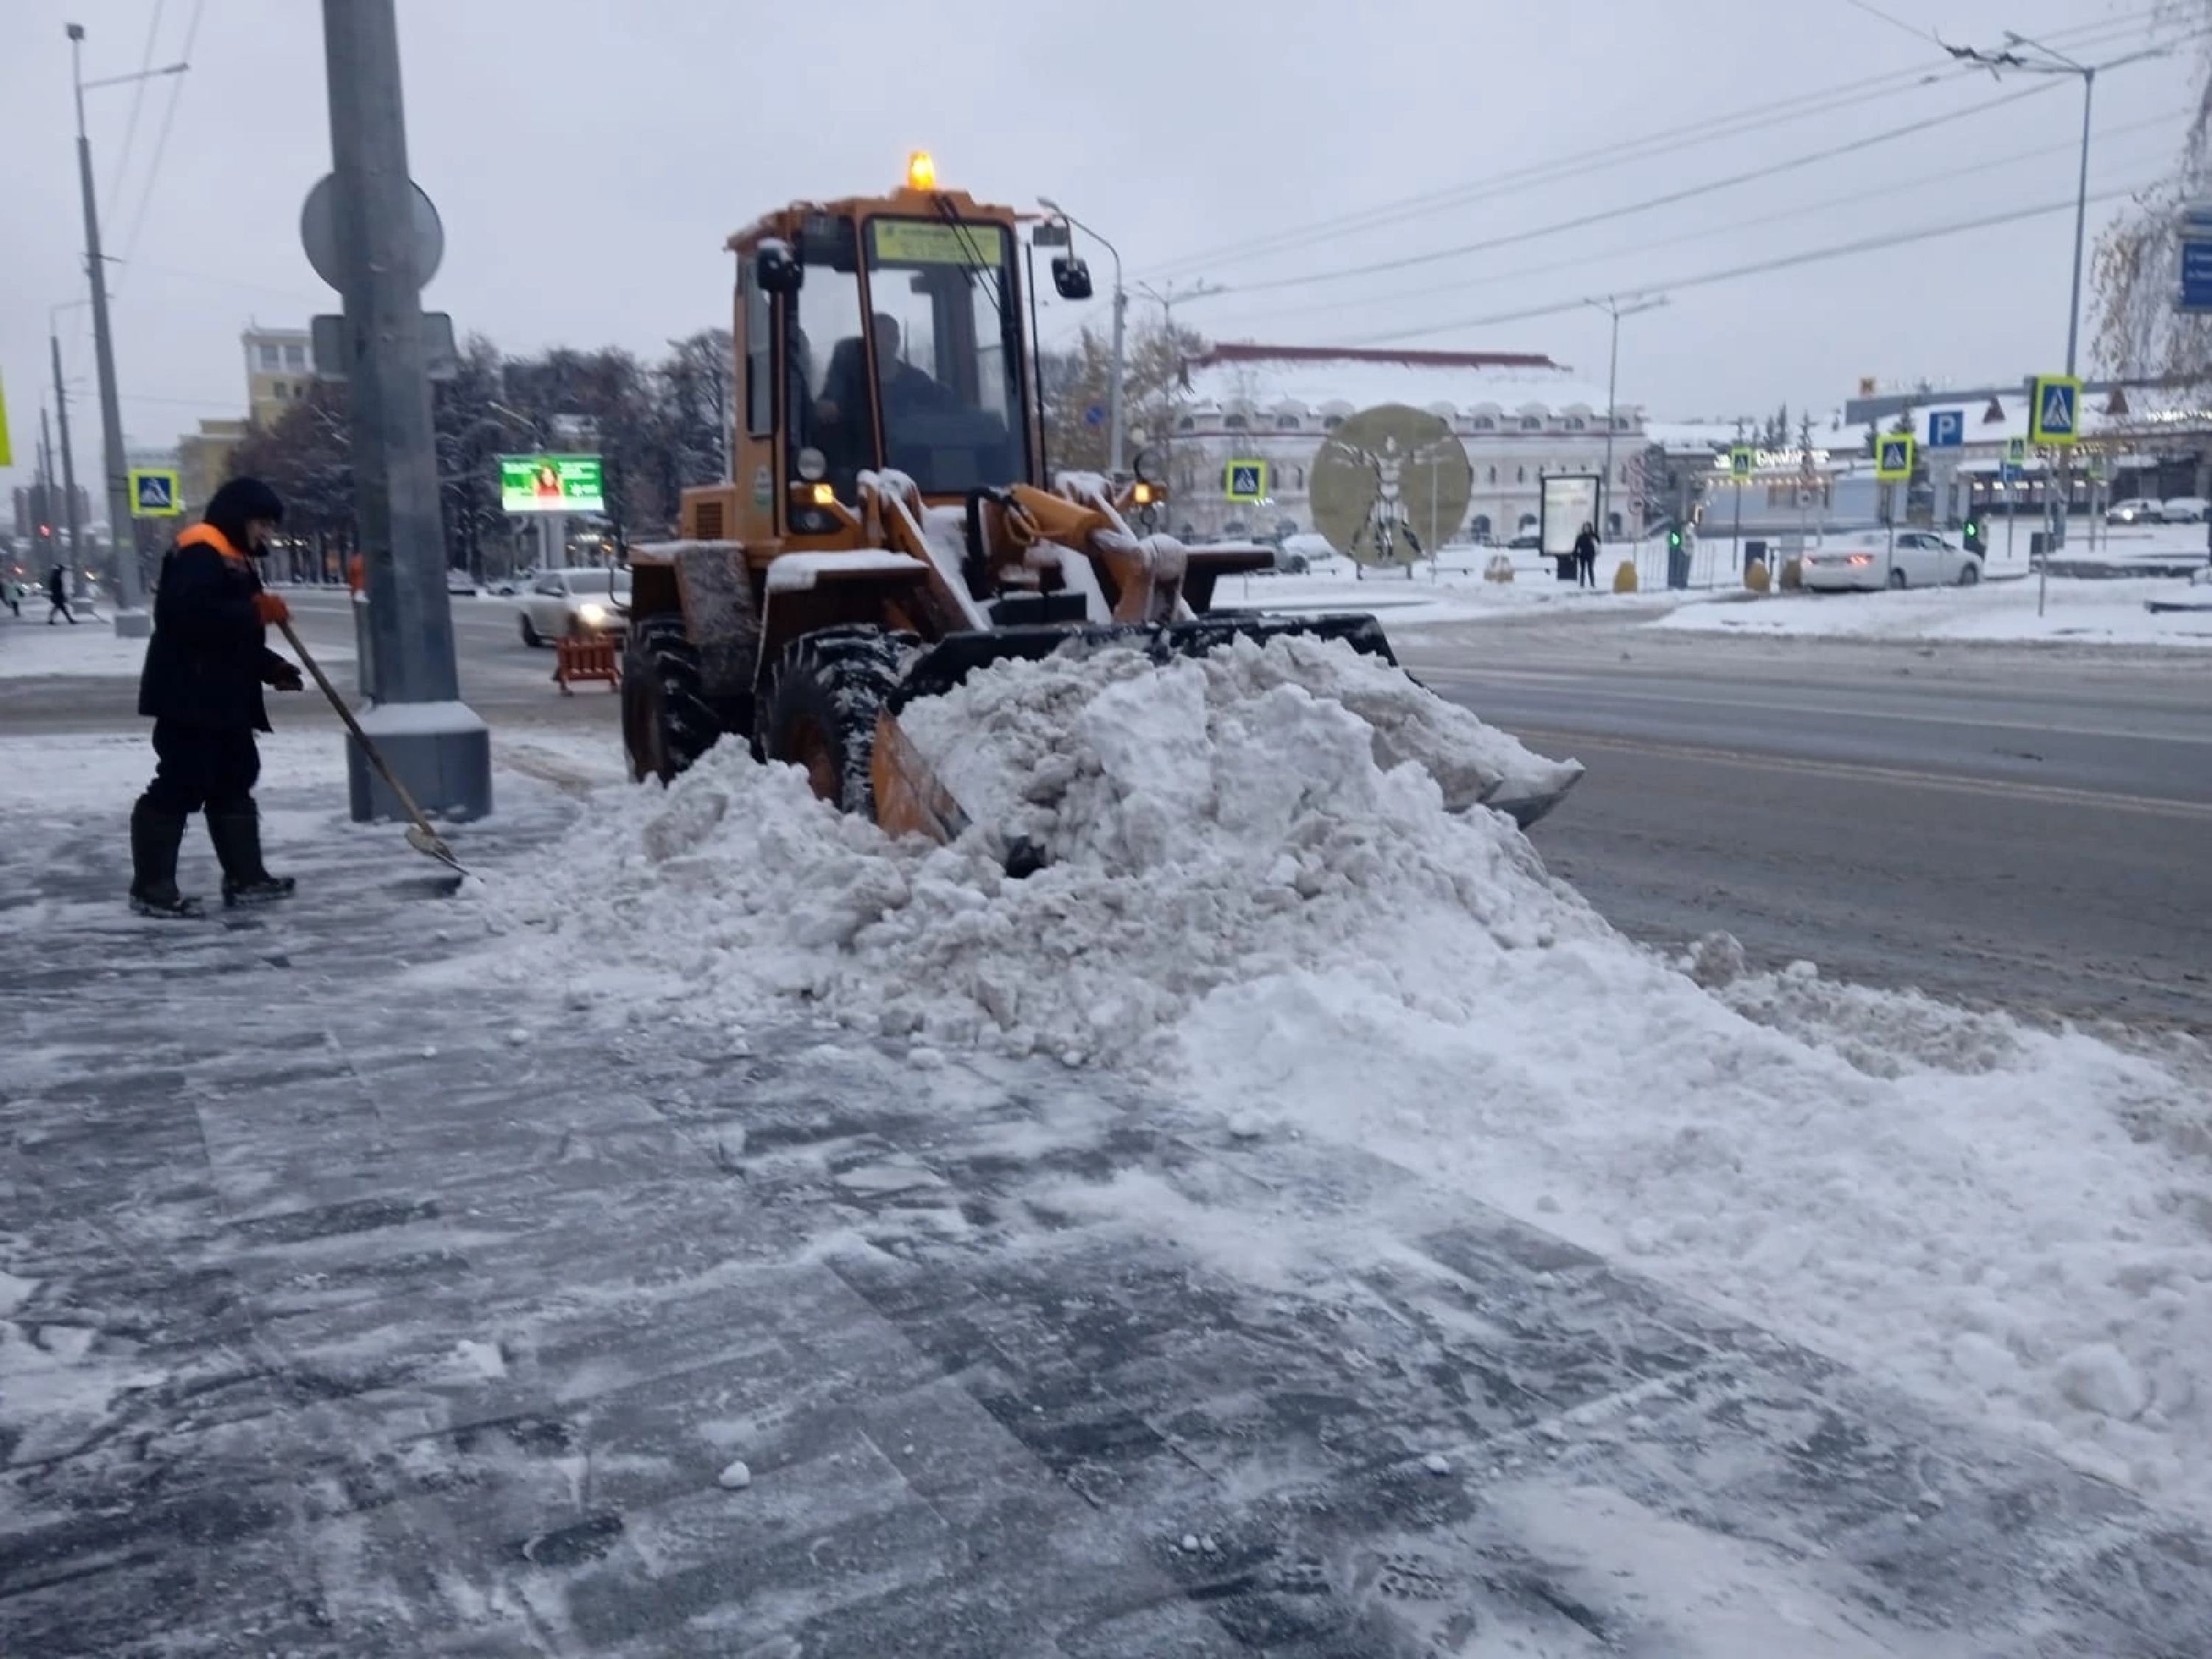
1188, 343, 1635, 416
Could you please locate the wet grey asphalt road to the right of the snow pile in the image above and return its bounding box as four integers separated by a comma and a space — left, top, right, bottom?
1398, 622, 2212, 1033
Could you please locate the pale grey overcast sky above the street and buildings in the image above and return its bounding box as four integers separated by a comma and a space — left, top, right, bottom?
0, 0, 2197, 500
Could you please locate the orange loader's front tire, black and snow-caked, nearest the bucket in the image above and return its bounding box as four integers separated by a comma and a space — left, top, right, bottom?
754, 626, 916, 821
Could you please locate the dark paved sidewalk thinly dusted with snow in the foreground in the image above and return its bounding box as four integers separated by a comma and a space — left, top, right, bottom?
0, 774, 2212, 1659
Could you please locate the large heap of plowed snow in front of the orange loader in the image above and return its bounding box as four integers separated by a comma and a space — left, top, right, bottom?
467, 641, 2212, 1513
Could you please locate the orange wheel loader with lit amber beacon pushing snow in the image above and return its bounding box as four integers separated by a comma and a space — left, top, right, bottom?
622, 155, 1566, 863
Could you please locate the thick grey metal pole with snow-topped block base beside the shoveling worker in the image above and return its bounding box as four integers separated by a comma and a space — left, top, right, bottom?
323, 0, 491, 823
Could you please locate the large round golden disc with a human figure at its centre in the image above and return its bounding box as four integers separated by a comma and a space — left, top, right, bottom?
1314, 403, 1475, 566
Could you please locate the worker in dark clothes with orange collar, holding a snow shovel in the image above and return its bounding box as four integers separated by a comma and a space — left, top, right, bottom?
131, 478, 301, 916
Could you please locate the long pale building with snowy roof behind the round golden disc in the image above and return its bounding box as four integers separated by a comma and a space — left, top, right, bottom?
1155, 343, 1644, 542
